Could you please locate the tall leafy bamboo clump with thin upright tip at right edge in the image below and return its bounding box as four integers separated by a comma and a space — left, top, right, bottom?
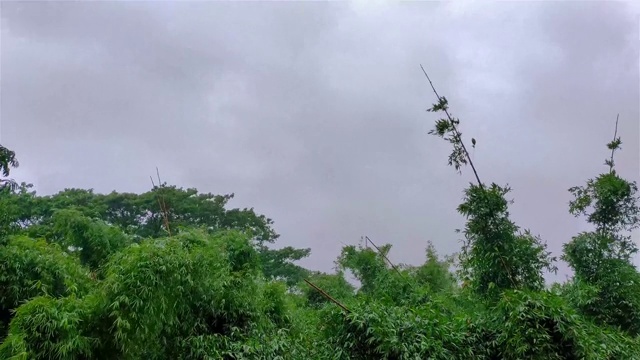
563, 130, 640, 336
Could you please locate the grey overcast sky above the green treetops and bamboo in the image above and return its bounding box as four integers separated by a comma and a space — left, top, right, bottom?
0, 1, 640, 280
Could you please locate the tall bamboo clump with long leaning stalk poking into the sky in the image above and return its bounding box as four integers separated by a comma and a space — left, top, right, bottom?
422, 69, 557, 300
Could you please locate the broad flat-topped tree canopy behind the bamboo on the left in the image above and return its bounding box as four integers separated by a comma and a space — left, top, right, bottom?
0, 184, 310, 286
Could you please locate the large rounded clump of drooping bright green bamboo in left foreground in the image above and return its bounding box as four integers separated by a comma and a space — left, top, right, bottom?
2, 231, 308, 359
